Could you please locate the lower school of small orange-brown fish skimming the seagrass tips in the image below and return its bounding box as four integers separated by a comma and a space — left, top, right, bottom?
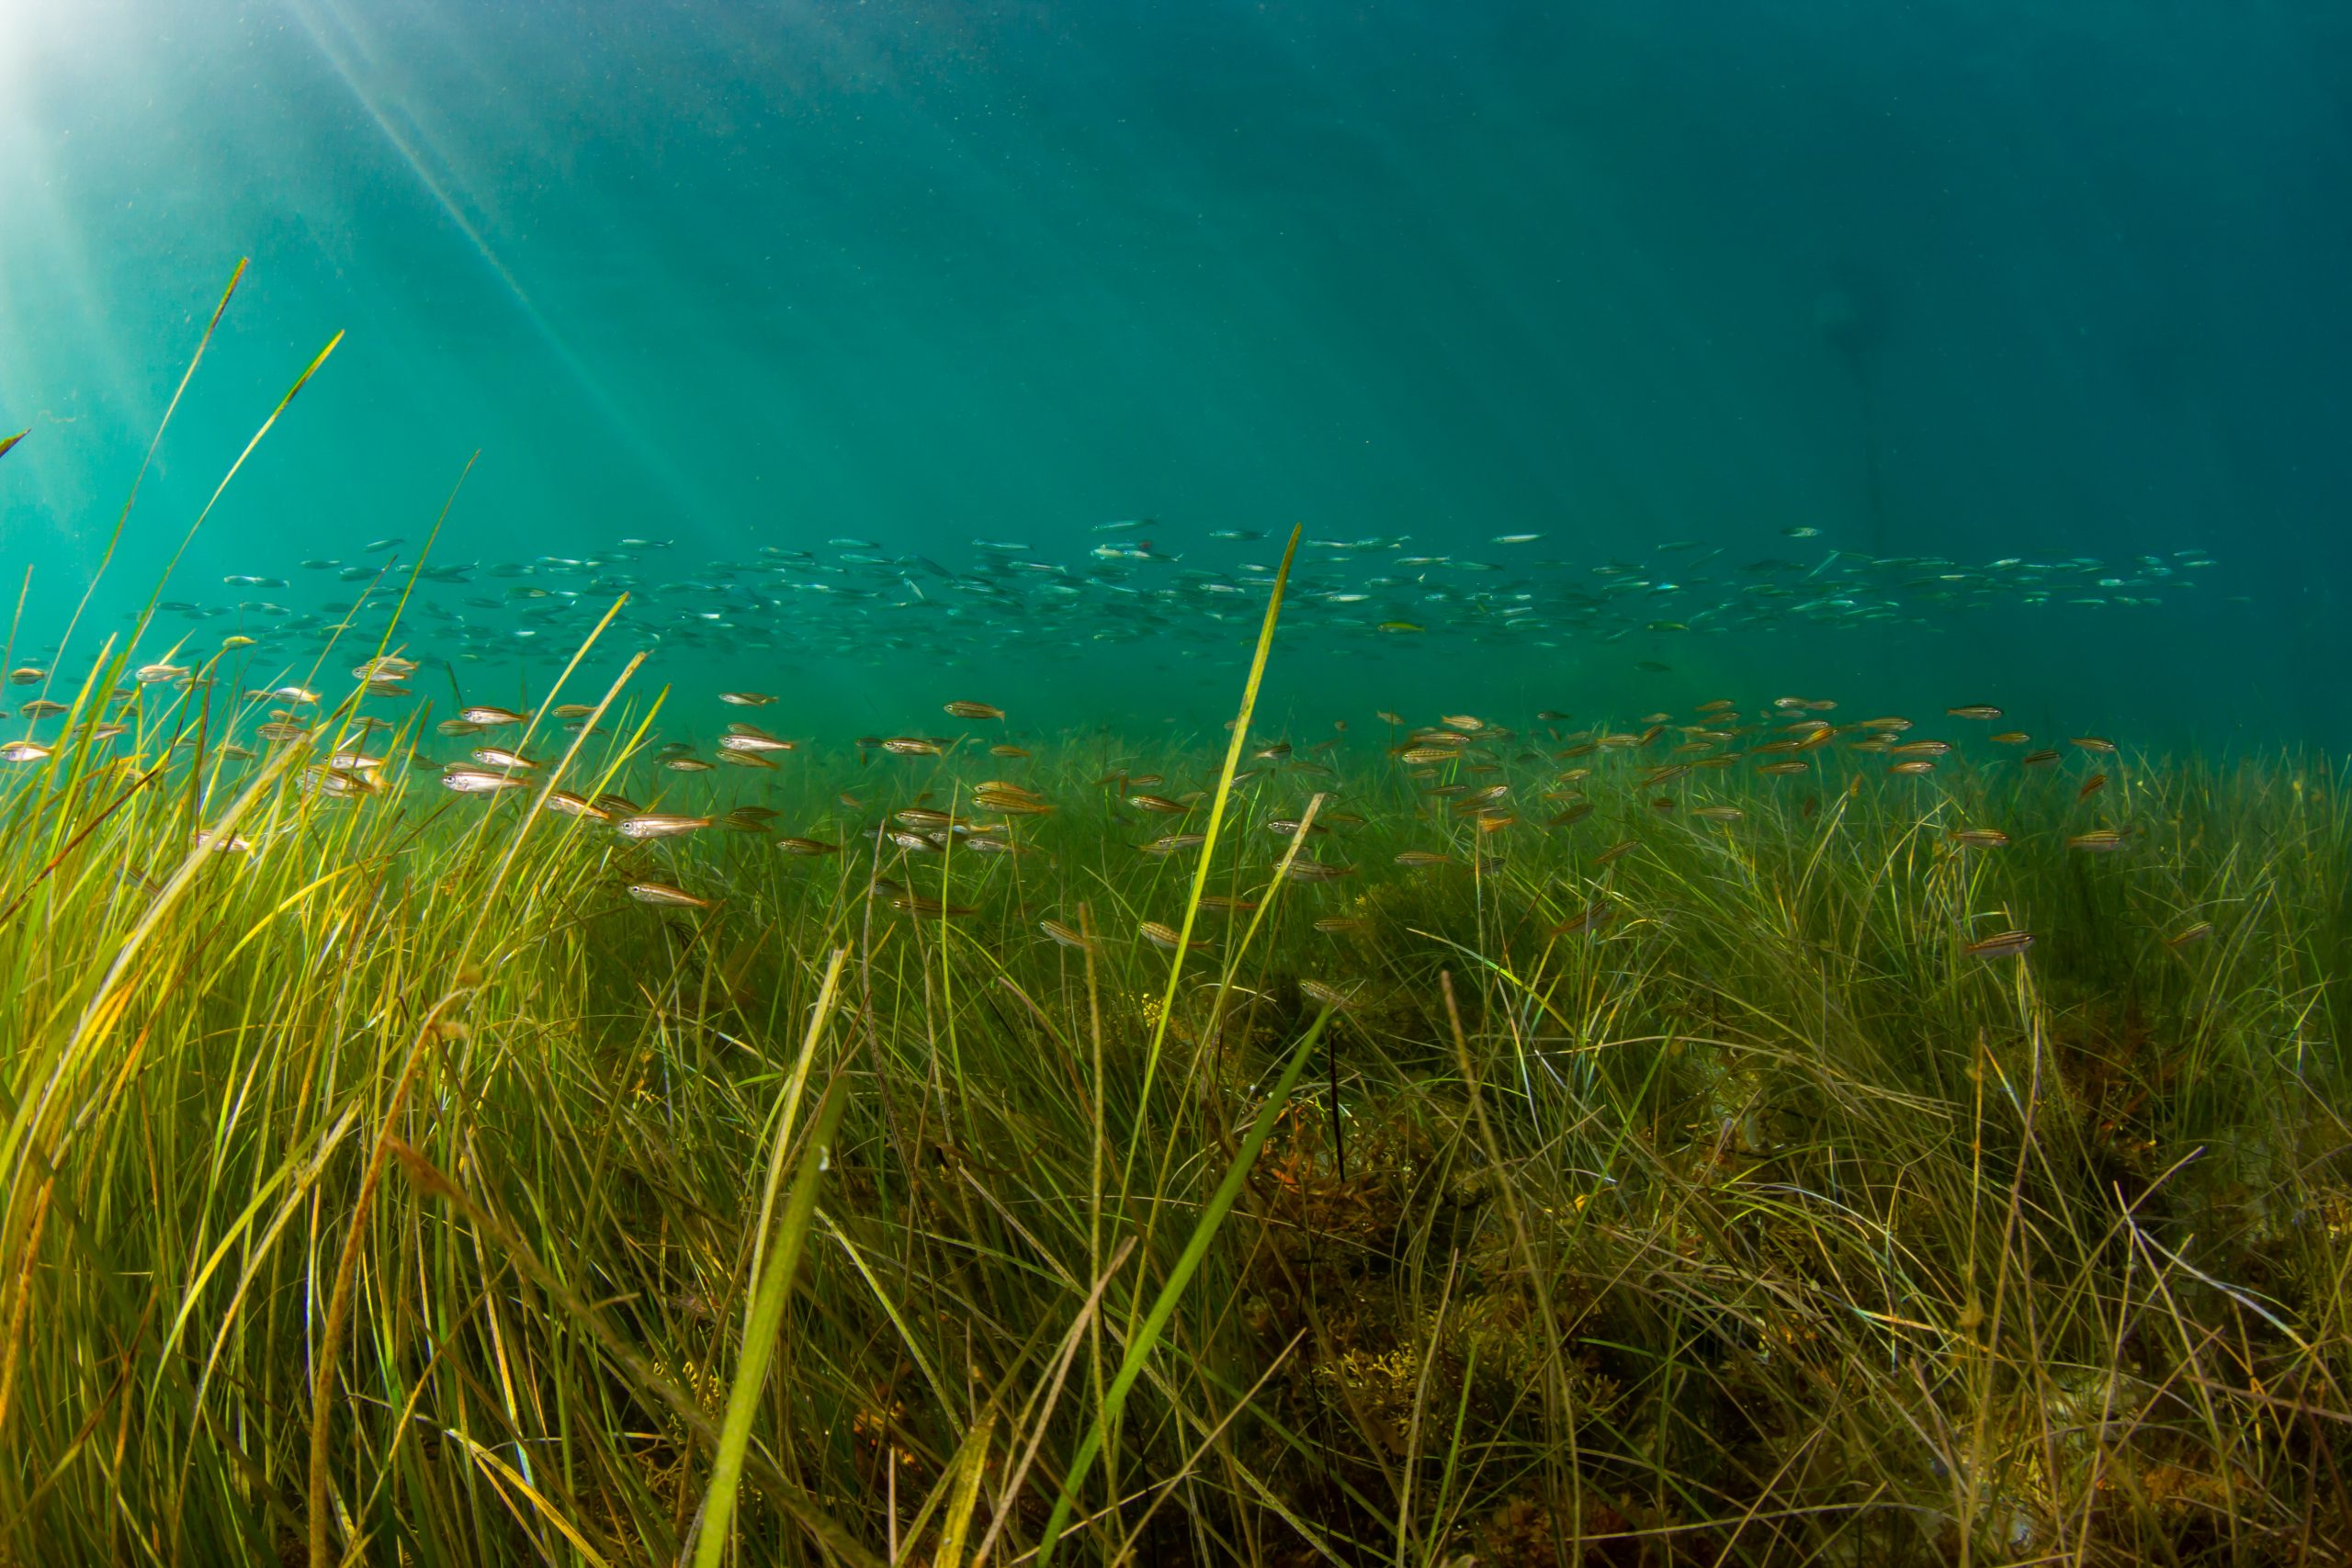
0, 653, 2213, 959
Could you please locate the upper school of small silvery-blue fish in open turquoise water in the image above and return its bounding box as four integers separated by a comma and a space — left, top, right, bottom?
18, 517, 2213, 670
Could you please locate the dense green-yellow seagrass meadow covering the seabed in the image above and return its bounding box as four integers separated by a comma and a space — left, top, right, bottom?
0, 300, 2352, 1568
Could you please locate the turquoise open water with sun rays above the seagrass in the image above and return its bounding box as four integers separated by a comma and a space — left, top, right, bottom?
0, 0, 2352, 743
